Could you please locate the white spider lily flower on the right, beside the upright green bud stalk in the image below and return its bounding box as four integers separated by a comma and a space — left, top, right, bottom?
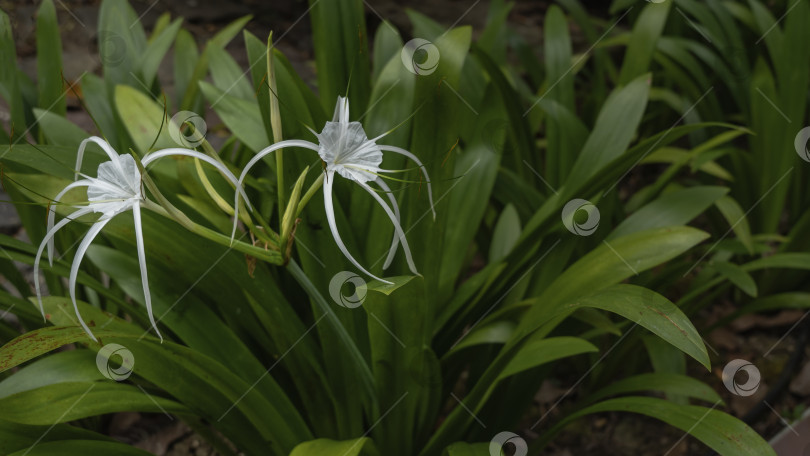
231, 97, 436, 284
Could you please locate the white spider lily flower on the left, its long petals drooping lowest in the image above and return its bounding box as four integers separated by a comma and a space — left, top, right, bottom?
34, 136, 250, 341
